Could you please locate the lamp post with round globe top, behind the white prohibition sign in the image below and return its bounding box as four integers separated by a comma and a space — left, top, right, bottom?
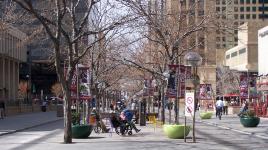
184, 52, 202, 143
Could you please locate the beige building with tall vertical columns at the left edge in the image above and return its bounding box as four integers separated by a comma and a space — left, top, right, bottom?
0, 26, 27, 101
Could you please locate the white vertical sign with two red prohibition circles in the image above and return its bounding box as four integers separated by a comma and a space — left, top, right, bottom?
185, 91, 194, 117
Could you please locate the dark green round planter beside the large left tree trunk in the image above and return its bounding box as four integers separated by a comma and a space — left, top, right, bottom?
72, 125, 93, 139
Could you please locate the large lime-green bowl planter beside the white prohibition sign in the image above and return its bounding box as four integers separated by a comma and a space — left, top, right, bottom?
163, 124, 191, 139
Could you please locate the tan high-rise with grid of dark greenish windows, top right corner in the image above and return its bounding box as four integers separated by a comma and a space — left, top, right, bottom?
214, 0, 268, 49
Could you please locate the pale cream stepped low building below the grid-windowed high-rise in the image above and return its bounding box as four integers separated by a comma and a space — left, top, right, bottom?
225, 21, 267, 72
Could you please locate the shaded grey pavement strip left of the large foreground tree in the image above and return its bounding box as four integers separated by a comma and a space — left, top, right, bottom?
0, 111, 63, 136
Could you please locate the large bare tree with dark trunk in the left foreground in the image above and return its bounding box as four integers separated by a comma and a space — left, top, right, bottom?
14, 0, 133, 143
